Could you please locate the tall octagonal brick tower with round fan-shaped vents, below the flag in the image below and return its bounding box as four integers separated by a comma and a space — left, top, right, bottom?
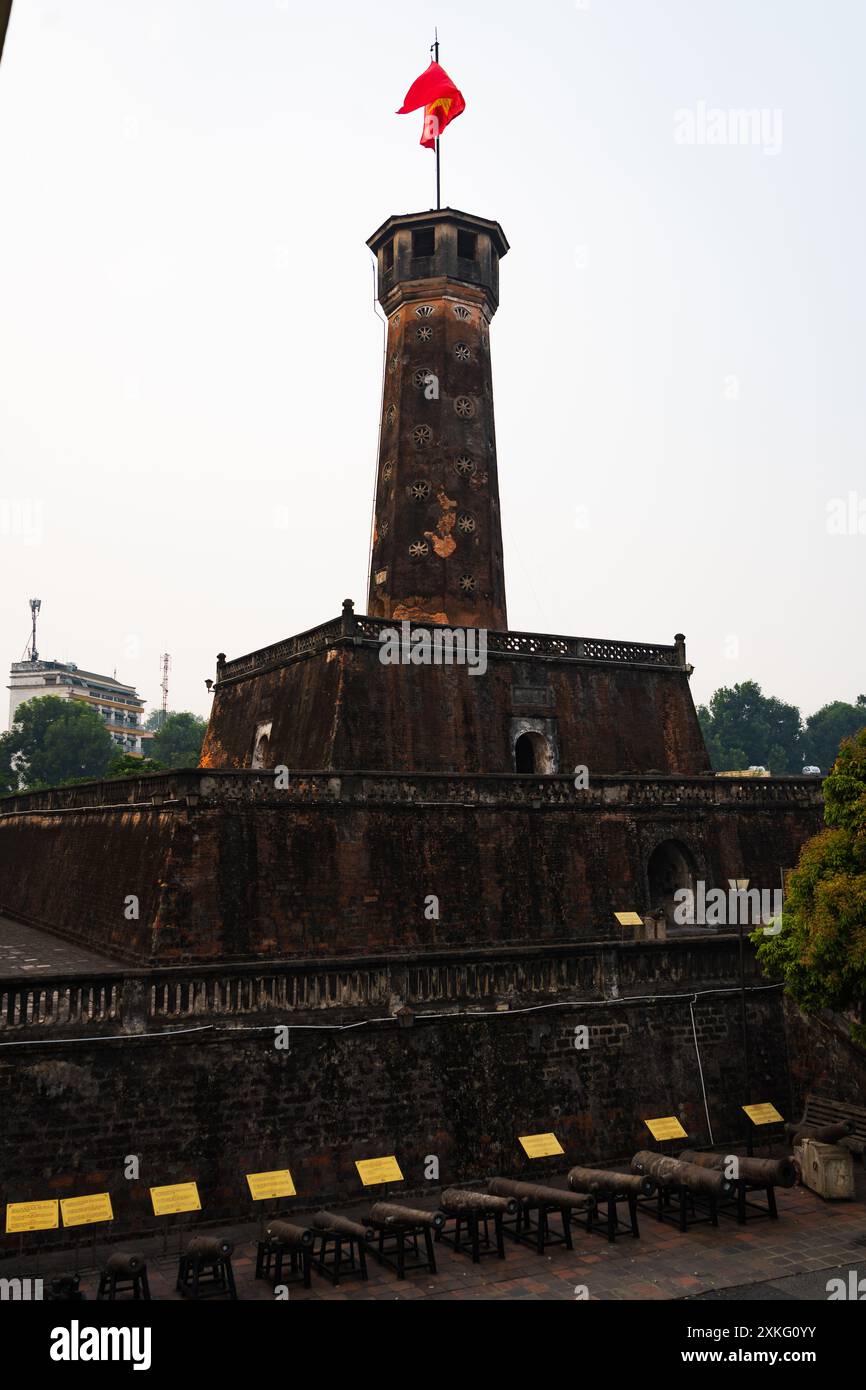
367, 207, 509, 631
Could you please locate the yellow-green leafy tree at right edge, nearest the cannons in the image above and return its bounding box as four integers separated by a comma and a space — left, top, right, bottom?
752, 728, 866, 1043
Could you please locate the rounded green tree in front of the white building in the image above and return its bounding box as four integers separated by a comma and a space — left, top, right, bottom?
4, 695, 115, 788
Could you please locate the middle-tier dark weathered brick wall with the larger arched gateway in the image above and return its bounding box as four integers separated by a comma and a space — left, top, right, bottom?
0, 771, 820, 963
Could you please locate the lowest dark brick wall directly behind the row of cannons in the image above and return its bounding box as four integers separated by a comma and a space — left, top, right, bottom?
0, 974, 790, 1252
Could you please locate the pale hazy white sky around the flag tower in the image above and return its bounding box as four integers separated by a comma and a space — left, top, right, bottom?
0, 0, 866, 727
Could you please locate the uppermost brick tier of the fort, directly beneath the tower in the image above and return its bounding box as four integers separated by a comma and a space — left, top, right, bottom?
202, 619, 710, 776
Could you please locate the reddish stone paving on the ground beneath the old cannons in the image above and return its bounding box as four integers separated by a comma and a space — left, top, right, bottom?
15, 1166, 866, 1302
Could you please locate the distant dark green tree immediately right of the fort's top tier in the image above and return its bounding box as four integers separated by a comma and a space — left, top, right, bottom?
698, 681, 803, 776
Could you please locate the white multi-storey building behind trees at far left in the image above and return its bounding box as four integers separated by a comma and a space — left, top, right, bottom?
8, 659, 153, 758
